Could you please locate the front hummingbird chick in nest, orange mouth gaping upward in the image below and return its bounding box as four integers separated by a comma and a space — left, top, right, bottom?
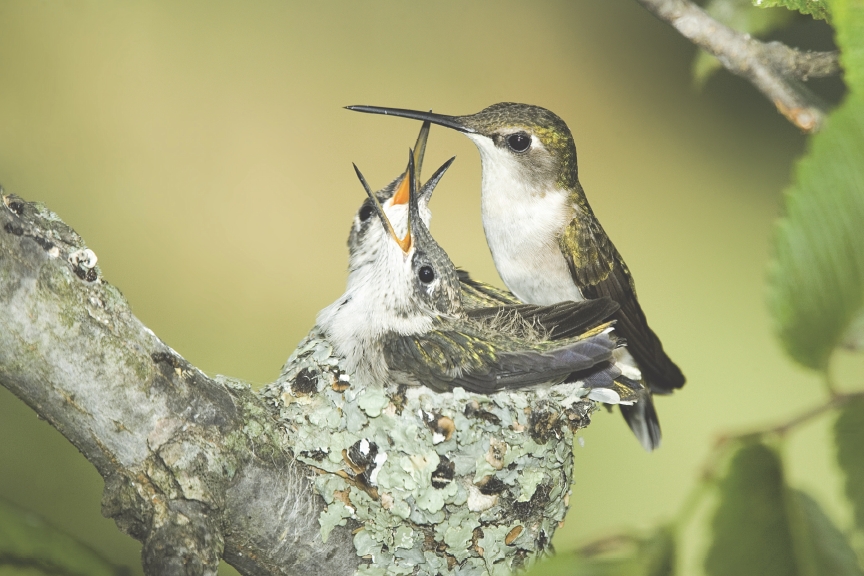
318, 154, 633, 402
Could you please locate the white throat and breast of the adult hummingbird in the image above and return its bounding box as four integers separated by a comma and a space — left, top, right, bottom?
467, 134, 584, 305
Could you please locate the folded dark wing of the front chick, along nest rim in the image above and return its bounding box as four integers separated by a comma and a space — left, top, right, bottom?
384, 330, 617, 394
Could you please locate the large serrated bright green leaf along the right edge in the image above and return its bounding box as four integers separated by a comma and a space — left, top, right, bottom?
769, 0, 864, 371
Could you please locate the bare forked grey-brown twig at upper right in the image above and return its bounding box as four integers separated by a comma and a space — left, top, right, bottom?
638, 0, 840, 132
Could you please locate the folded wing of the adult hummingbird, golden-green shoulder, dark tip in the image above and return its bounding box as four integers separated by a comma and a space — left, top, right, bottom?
560, 212, 685, 394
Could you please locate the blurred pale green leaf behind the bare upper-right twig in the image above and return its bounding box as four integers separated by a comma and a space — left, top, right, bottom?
693, 0, 794, 88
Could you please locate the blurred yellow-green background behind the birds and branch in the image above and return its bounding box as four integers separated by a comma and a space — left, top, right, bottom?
0, 0, 862, 575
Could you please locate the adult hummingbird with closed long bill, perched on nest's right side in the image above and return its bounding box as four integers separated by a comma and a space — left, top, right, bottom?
340, 102, 685, 450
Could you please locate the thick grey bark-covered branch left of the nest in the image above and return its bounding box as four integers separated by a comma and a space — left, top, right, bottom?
0, 190, 357, 575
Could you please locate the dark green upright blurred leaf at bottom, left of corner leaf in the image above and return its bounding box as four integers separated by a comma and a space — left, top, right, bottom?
705, 444, 798, 576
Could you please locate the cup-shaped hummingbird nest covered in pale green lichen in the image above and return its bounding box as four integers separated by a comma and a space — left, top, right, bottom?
262, 329, 596, 576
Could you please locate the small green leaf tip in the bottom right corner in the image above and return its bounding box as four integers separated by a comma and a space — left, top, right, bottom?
788, 490, 864, 576
